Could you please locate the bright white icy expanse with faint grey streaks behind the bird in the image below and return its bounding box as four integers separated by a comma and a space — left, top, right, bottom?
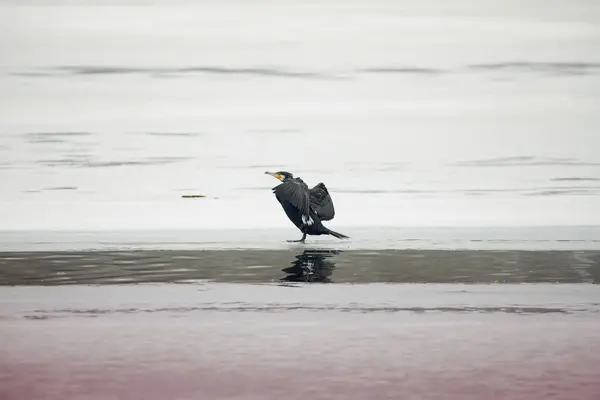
0, 0, 600, 230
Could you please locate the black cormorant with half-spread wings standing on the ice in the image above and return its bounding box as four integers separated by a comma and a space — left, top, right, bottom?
265, 171, 349, 243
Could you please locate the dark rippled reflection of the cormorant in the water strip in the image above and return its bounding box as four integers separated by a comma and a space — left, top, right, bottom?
281, 249, 341, 283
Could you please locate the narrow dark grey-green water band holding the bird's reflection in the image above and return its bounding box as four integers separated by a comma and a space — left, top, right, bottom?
0, 246, 600, 285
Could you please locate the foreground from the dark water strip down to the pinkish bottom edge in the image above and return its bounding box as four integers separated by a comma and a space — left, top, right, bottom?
0, 245, 600, 400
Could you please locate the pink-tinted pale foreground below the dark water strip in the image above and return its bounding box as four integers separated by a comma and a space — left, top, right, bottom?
0, 285, 600, 400
